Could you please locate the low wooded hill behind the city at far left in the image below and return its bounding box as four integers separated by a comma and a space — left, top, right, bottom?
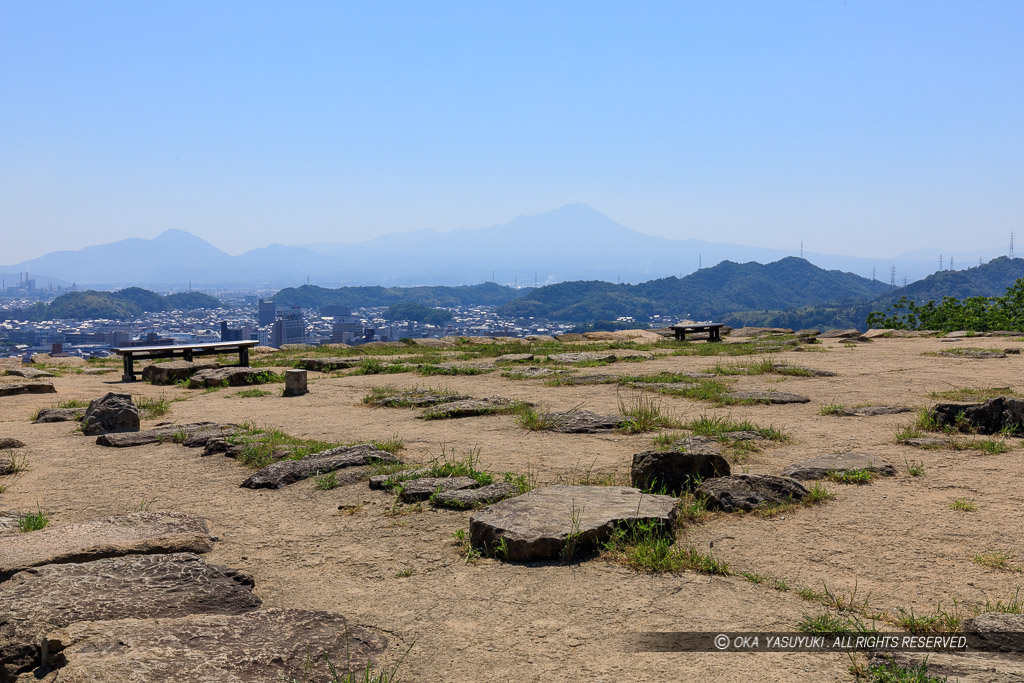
5, 287, 220, 321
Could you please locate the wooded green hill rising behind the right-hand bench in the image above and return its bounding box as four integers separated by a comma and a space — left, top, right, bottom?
500, 257, 888, 322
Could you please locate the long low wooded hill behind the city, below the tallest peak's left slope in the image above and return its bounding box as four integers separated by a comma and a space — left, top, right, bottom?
273, 283, 529, 308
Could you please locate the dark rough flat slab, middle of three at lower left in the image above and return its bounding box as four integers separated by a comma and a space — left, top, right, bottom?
0, 553, 262, 676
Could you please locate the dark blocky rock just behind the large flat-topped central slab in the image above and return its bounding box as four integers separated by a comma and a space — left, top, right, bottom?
630, 444, 730, 494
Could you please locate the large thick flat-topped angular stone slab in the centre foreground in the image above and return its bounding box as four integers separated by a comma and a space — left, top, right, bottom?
469, 486, 678, 561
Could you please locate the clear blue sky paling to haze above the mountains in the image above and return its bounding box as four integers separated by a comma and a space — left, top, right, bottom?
0, 0, 1024, 263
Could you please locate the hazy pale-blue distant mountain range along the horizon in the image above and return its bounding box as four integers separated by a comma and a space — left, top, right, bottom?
0, 204, 1007, 289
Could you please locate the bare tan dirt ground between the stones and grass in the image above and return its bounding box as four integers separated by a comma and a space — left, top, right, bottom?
0, 338, 1024, 683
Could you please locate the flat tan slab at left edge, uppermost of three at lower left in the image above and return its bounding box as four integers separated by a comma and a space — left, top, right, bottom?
0, 512, 213, 581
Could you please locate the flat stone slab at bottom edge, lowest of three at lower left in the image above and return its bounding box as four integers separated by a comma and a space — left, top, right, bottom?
42, 609, 387, 683
